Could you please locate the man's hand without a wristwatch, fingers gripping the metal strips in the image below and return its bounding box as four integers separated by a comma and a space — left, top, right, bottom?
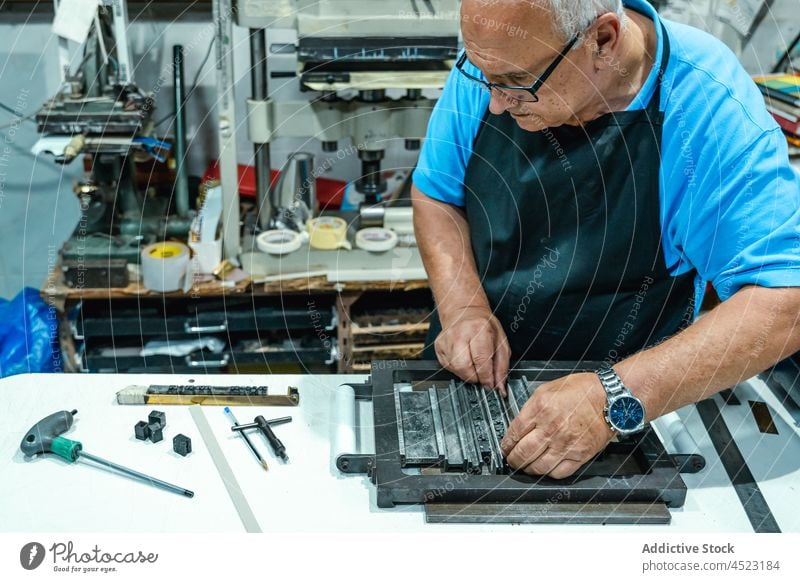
434, 307, 511, 397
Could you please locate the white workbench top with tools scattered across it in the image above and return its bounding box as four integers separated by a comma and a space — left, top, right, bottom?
0, 374, 800, 533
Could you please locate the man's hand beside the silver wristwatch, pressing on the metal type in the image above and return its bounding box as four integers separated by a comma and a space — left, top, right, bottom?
501, 373, 614, 479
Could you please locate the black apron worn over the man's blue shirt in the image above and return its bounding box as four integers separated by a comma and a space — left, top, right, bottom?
425, 25, 695, 364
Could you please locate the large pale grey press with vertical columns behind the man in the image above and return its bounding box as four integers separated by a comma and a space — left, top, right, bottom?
215, 0, 459, 257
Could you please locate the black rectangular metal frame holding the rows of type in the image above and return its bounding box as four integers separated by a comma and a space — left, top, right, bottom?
350, 360, 686, 508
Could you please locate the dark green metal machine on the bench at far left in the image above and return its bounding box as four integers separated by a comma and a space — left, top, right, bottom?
33, 0, 191, 287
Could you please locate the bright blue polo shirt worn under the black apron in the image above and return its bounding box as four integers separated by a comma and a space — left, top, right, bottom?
413, 0, 800, 306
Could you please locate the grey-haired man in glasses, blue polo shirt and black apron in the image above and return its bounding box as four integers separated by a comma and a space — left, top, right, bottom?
412, 0, 800, 478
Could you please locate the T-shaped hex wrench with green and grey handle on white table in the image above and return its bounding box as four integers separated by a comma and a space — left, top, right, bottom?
19, 410, 194, 497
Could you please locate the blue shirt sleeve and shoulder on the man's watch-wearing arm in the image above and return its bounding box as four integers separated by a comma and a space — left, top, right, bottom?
661, 25, 800, 300
